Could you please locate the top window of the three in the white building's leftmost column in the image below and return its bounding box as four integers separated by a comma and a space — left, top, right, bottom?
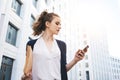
12, 0, 22, 16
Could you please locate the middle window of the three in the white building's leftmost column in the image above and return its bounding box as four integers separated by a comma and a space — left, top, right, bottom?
6, 23, 18, 46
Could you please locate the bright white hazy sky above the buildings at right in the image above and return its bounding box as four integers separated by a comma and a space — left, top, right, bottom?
71, 0, 120, 58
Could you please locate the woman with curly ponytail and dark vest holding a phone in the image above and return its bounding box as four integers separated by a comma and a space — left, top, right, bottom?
24, 11, 87, 80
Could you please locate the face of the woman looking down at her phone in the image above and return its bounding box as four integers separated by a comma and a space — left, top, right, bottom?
47, 16, 61, 35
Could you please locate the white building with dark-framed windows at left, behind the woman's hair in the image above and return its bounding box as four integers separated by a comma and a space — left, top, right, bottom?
0, 0, 64, 80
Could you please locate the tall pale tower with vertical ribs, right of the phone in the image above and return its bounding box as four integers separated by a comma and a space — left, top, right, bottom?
86, 28, 112, 80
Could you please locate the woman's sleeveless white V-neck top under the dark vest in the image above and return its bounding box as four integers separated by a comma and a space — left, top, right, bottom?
32, 37, 61, 80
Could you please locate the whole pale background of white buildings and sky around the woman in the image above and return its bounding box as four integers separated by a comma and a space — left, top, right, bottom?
0, 0, 120, 80
